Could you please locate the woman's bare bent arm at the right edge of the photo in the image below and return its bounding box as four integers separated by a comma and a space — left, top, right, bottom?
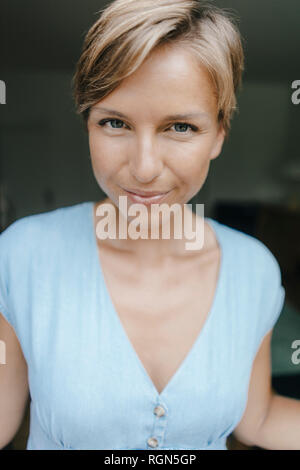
233, 330, 300, 450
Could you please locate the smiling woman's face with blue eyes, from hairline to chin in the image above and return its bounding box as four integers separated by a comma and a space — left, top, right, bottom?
88, 46, 224, 212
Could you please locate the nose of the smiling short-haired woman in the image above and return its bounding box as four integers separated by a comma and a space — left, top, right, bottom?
129, 133, 164, 184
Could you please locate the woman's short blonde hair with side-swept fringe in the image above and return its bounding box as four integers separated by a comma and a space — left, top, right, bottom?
72, 0, 244, 135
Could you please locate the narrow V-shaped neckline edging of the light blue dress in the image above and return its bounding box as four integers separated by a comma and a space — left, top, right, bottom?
88, 201, 225, 400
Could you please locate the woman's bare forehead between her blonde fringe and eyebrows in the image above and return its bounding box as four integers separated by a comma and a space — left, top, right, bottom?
96, 45, 216, 112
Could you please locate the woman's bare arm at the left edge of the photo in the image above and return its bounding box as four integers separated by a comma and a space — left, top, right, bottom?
0, 313, 29, 449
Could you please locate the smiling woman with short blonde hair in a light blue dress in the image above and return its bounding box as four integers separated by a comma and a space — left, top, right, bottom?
0, 0, 300, 450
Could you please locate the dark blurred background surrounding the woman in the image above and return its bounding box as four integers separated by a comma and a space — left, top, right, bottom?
0, 0, 300, 449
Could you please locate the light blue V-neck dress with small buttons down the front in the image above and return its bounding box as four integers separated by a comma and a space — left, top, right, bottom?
0, 201, 285, 450
